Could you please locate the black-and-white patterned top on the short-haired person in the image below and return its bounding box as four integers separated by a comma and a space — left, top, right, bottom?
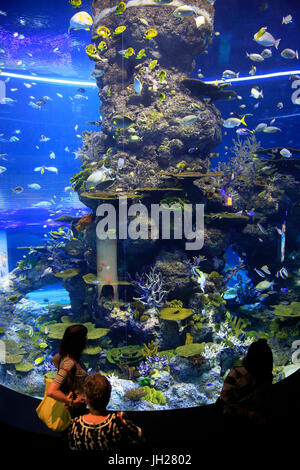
68, 412, 142, 452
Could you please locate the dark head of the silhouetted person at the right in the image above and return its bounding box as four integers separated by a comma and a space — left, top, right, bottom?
243, 339, 273, 381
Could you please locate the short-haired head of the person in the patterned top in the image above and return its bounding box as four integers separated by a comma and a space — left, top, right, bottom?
83, 374, 111, 411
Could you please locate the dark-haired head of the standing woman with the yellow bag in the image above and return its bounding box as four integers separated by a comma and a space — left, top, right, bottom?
59, 325, 87, 361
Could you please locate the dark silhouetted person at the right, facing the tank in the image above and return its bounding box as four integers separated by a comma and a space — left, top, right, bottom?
217, 339, 273, 424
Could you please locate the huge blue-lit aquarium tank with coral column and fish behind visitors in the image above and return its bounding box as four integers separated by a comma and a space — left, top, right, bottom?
0, 0, 300, 411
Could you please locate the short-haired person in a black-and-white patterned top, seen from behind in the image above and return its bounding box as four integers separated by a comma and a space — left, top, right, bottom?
69, 374, 143, 453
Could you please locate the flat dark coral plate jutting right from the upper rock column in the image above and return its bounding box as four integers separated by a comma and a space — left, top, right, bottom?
181, 78, 237, 101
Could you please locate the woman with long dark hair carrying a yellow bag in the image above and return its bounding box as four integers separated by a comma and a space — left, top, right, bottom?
47, 324, 87, 417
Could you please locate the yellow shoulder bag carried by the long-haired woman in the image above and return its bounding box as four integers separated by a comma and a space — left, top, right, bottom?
36, 375, 72, 432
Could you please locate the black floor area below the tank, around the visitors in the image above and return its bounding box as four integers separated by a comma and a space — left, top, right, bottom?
0, 371, 300, 460
